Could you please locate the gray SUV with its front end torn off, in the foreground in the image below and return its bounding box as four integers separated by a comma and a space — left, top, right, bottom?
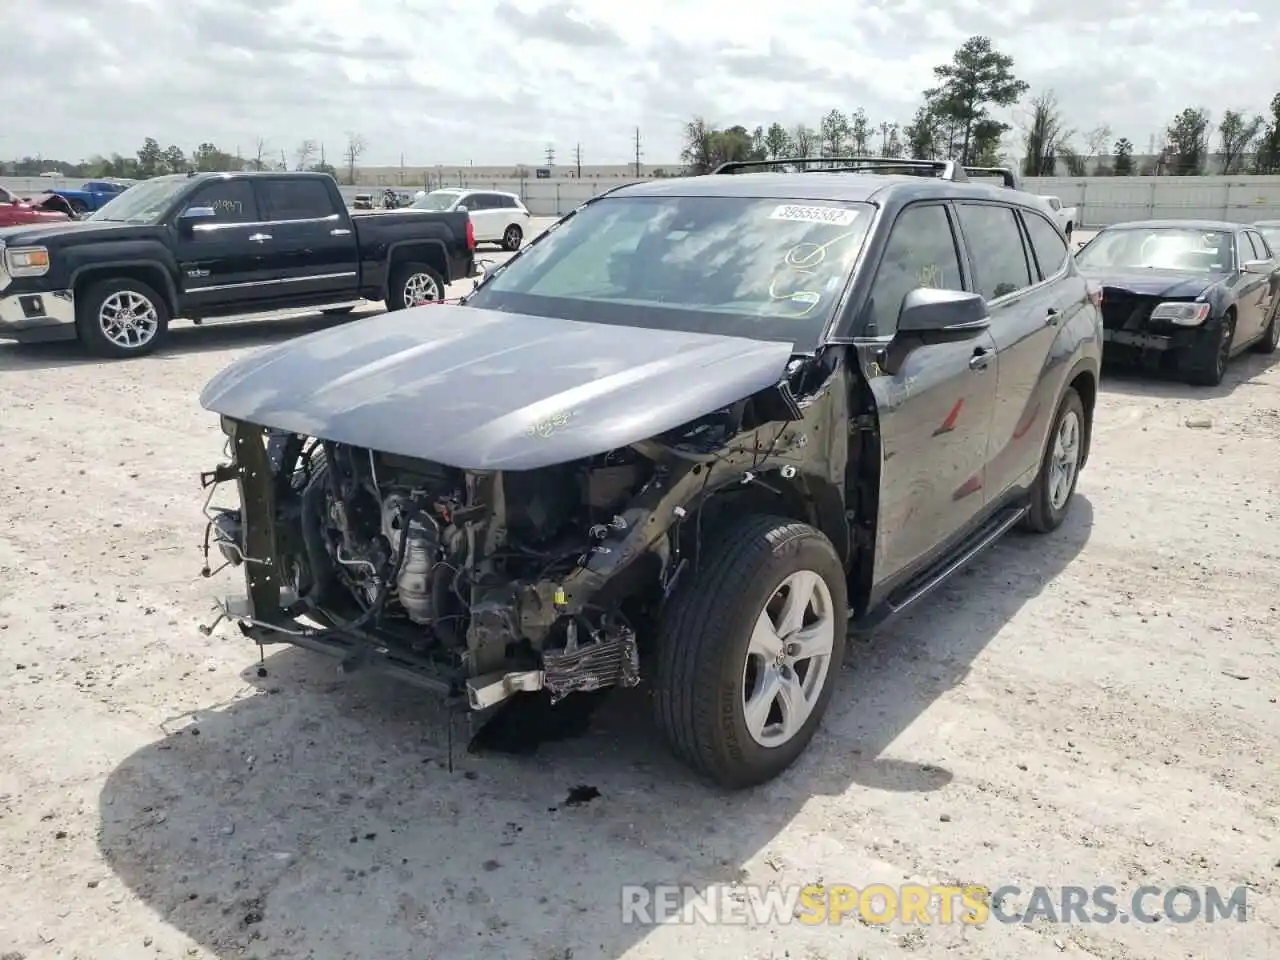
201, 157, 1102, 787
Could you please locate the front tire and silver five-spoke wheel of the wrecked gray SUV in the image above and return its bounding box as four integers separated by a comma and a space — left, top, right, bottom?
654, 515, 849, 790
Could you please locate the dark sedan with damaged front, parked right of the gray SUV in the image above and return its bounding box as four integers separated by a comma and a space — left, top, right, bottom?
1075, 220, 1280, 387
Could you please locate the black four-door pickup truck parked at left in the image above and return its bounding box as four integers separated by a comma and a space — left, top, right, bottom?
0, 173, 477, 357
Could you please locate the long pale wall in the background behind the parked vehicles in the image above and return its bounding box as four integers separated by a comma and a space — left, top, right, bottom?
0, 177, 1280, 227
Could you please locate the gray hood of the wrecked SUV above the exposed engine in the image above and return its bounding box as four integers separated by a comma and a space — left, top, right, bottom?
200, 305, 792, 470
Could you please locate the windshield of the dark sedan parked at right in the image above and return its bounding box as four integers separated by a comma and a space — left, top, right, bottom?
1075, 227, 1235, 274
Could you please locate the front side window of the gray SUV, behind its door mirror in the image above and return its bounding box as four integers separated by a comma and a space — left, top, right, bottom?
865, 204, 964, 337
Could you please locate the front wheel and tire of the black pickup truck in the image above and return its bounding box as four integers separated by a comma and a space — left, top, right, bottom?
76, 276, 170, 360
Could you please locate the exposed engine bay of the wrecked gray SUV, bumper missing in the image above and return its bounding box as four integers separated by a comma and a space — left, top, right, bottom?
202, 353, 847, 710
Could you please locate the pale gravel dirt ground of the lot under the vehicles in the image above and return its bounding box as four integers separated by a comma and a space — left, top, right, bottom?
0, 231, 1280, 960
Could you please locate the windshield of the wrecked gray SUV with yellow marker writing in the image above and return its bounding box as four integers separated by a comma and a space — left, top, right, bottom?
467, 197, 874, 349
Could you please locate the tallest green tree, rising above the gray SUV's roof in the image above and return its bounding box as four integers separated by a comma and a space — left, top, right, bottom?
924, 36, 1029, 164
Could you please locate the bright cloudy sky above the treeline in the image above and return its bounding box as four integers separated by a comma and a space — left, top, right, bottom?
0, 0, 1280, 164
